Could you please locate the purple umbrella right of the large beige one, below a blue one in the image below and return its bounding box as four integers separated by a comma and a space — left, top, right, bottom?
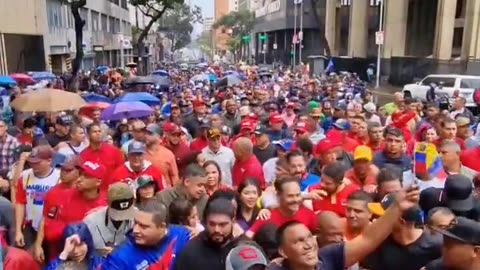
102, 101, 153, 120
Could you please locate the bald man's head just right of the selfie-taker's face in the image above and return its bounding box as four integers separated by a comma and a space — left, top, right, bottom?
315, 211, 345, 248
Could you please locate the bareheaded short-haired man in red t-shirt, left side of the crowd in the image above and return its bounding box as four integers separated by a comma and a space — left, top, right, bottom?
80, 124, 125, 190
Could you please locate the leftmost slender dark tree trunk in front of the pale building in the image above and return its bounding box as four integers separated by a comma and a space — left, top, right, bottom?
62, 0, 87, 92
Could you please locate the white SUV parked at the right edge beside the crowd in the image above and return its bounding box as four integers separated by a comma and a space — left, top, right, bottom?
402, 74, 480, 108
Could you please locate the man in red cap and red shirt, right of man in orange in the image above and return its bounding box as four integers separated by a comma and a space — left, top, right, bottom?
162, 122, 190, 171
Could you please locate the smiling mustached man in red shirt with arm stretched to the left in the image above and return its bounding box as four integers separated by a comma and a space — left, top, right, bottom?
245, 177, 317, 238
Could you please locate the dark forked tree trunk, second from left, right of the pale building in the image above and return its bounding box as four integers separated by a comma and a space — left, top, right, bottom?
130, 0, 184, 73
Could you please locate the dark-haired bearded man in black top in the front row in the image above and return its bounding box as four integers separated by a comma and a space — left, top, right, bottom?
174, 198, 238, 270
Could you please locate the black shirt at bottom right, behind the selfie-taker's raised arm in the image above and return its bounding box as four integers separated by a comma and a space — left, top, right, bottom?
360, 232, 443, 270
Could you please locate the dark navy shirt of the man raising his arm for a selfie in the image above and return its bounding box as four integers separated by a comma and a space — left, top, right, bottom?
267, 244, 345, 270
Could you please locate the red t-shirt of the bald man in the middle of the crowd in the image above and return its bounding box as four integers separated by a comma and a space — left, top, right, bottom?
232, 155, 265, 188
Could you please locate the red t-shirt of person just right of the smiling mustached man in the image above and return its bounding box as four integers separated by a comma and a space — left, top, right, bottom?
308, 184, 360, 217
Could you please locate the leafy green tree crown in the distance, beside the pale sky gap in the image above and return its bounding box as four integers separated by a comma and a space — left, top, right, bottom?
158, 4, 203, 52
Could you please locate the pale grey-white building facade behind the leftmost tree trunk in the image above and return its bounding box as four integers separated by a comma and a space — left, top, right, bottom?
44, 0, 132, 73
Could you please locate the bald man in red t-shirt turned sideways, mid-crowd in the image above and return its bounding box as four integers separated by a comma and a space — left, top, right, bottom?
232, 137, 265, 189
